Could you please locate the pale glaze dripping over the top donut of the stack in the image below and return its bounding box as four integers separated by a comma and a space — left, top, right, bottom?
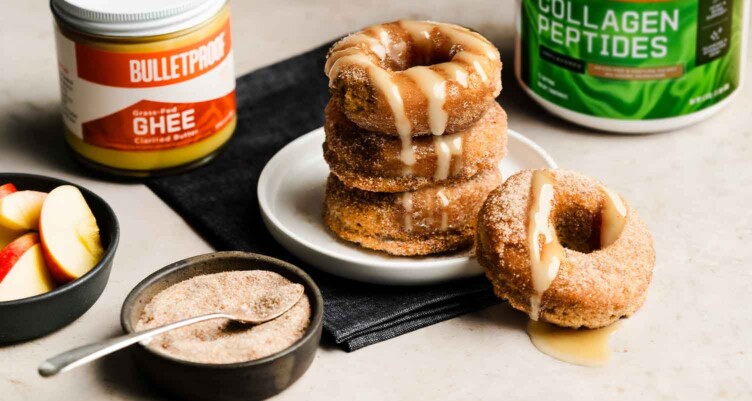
325, 20, 499, 175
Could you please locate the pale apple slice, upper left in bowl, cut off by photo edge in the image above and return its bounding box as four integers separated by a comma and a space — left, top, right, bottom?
0, 191, 47, 230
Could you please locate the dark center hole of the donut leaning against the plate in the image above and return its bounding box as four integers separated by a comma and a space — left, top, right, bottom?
553, 204, 600, 253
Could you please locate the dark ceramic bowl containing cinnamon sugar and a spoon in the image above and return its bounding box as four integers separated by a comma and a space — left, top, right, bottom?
120, 252, 324, 401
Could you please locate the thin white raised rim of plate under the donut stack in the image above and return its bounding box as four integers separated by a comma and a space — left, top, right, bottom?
256, 126, 558, 270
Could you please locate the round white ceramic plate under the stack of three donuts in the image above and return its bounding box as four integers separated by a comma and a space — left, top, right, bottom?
258, 128, 556, 285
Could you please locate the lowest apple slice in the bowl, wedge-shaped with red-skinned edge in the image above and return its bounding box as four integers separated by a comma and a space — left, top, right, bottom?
0, 241, 55, 302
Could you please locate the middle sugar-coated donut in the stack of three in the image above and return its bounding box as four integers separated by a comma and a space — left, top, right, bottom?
324, 101, 507, 192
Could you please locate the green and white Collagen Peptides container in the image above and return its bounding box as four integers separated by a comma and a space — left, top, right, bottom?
515, 0, 750, 133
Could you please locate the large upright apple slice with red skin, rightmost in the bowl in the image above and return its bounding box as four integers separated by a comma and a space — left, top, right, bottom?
39, 185, 104, 283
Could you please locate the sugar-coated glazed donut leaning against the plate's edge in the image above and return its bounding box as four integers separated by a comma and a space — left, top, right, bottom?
477, 170, 655, 328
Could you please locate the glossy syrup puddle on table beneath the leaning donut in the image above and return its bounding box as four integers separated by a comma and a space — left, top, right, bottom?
527, 320, 621, 367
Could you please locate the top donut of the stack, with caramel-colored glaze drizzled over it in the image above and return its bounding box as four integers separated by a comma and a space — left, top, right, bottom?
324, 20, 501, 136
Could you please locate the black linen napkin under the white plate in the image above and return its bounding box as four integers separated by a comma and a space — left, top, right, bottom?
147, 44, 497, 351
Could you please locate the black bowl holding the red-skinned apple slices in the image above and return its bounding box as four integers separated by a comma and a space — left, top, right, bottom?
0, 173, 120, 344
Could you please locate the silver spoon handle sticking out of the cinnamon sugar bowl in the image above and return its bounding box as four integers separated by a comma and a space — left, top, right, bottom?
39, 313, 232, 377
